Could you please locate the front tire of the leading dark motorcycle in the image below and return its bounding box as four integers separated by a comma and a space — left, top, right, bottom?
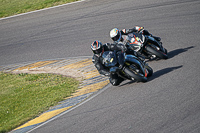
124, 67, 147, 82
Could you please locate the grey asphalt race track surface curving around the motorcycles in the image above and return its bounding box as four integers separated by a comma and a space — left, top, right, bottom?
0, 0, 200, 133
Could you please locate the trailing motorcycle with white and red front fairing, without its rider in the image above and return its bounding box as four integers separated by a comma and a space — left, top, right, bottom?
125, 32, 168, 59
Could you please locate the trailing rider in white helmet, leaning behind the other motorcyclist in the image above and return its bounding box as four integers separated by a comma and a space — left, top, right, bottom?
110, 26, 162, 59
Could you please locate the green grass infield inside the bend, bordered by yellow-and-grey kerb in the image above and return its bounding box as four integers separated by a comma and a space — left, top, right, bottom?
0, 73, 79, 133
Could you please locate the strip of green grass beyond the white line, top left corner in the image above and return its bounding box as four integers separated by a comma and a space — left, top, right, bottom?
0, 0, 78, 18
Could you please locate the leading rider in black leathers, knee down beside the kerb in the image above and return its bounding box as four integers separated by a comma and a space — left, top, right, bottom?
91, 41, 126, 86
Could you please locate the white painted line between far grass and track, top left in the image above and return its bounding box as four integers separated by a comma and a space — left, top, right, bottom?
0, 0, 85, 20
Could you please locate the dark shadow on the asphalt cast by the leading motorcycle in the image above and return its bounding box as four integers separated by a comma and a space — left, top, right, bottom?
118, 65, 183, 87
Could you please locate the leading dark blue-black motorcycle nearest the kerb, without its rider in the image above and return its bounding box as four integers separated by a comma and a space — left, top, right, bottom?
102, 51, 153, 82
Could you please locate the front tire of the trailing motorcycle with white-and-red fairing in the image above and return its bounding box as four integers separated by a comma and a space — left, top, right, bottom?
146, 45, 168, 59
